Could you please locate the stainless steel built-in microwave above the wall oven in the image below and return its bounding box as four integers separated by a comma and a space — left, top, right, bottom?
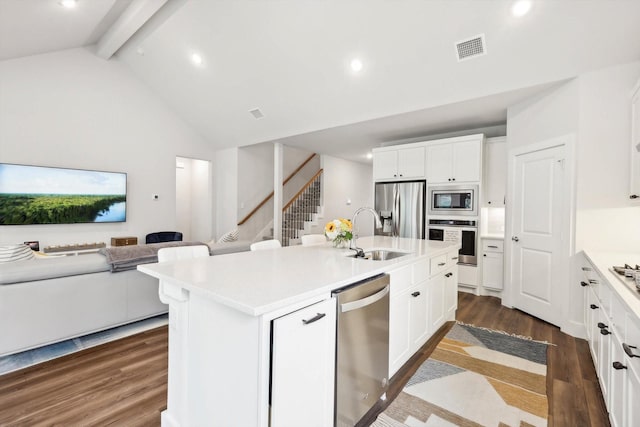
428, 185, 478, 216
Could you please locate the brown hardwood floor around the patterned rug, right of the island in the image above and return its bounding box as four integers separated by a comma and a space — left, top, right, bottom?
358, 292, 610, 427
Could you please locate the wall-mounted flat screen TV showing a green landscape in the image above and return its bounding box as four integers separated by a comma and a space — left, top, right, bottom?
0, 163, 127, 225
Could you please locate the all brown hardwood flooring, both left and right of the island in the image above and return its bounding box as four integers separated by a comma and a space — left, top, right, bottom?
0, 293, 609, 427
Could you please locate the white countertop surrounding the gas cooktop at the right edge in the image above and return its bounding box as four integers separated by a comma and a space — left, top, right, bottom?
584, 251, 640, 318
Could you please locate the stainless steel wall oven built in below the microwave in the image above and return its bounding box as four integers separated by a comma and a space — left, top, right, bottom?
429, 219, 478, 265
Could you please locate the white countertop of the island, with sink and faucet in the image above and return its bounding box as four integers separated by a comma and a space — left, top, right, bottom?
138, 236, 457, 316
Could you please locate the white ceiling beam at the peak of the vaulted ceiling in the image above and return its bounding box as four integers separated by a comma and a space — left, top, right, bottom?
96, 0, 167, 59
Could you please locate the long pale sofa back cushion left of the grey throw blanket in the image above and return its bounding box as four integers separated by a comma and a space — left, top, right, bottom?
0, 254, 109, 285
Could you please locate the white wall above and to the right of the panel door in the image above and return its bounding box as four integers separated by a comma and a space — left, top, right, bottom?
506, 62, 640, 340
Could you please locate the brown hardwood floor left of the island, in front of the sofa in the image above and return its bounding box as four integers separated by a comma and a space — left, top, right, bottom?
0, 326, 167, 427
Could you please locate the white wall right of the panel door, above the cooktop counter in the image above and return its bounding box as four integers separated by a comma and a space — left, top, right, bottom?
576, 62, 640, 252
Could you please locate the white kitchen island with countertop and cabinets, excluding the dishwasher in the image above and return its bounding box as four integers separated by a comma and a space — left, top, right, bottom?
138, 236, 459, 427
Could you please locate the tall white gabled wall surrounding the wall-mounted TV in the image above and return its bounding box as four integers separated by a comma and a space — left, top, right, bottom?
0, 48, 213, 247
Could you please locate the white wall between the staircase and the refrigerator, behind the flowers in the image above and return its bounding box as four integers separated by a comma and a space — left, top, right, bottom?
318, 155, 373, 236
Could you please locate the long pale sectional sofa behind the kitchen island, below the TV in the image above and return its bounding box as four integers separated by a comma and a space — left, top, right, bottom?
0, 242, 251, 356
